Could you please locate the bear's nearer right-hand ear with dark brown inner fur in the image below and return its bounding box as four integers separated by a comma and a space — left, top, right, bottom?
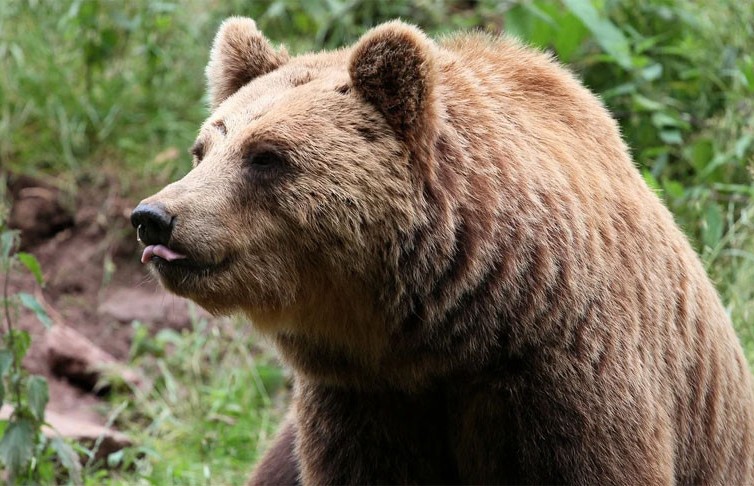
349, 21, 436, 148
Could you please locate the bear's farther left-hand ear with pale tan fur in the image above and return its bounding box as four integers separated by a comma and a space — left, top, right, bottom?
206, 17, 288, 110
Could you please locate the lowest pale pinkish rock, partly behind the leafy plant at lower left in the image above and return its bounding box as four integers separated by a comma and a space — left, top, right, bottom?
0, 405, 133, 459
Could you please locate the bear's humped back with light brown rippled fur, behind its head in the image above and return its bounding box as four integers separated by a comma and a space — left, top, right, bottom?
404, 36, 754, 483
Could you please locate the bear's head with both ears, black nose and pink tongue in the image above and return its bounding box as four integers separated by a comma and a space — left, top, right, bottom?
132, 18, 437, 338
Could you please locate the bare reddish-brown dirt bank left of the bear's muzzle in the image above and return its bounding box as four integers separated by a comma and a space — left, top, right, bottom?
8, 176, 204, 424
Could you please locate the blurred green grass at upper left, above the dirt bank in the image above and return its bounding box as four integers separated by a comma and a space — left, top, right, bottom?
0, 0, 214, 190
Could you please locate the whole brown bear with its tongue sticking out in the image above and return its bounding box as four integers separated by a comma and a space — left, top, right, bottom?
132, 18, 754, 485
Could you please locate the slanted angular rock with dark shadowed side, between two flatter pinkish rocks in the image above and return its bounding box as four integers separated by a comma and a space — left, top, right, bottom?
45, 324, 147, 391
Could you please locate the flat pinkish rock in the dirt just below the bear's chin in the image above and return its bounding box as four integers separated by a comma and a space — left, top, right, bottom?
97, 287, 209, 329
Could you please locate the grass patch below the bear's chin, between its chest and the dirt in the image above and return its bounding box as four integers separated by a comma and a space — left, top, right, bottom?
96, 319, 288, 484
